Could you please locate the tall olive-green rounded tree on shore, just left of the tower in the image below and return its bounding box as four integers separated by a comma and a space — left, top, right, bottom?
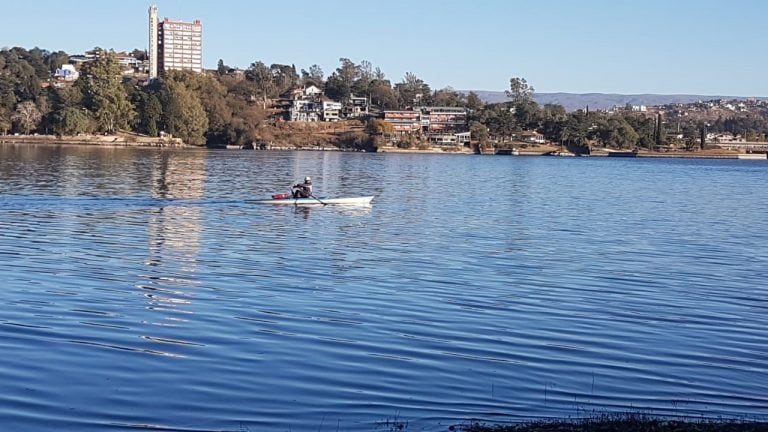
77, 50, 136, 134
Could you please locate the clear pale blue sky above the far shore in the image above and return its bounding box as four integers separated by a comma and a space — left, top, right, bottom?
0, 0, 768, 97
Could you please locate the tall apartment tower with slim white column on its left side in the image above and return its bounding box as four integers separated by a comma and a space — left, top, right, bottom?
149, 5, 203, 79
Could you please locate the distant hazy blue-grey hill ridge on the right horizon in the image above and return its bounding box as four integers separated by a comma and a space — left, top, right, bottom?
464, 90, 765, 111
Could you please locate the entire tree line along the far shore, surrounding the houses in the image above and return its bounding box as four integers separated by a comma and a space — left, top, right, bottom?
0, 47, 768, 149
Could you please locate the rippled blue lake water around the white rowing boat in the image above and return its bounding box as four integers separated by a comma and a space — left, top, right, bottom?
0, 145, 768, 431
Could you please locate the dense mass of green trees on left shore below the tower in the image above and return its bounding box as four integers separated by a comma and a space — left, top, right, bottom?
0, 48, 268, 146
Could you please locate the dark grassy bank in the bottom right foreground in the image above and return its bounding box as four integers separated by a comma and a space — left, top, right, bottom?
451, 416, 768, 432
